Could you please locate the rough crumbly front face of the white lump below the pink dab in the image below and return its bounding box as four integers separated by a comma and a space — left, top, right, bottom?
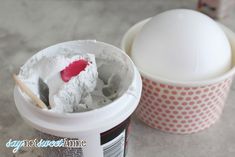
48, 54, 98, 112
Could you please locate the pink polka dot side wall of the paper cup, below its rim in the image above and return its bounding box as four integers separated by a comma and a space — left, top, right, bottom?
136, 77, 232, 134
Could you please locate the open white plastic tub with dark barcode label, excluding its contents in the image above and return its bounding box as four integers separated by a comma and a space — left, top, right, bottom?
14, 41, 142, 157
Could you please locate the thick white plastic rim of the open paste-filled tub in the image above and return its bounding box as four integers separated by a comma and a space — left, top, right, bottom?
14, 40, 142, 137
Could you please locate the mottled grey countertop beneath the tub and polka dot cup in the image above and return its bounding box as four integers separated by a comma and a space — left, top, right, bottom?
0, 0, 235, 157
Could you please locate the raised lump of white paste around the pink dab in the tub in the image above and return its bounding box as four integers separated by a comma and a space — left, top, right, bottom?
19, 49, 110, 112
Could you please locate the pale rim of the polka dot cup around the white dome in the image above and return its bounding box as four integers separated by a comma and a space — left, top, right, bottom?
121, 17, 235, 87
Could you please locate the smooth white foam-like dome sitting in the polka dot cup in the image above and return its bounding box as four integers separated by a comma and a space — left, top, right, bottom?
131, 9, 232, 81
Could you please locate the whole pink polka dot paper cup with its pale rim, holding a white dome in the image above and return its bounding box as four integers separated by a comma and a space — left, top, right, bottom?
121, 19, 235, 134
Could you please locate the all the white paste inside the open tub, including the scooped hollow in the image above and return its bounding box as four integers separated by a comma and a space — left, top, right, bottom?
19, 41, 132, 113
